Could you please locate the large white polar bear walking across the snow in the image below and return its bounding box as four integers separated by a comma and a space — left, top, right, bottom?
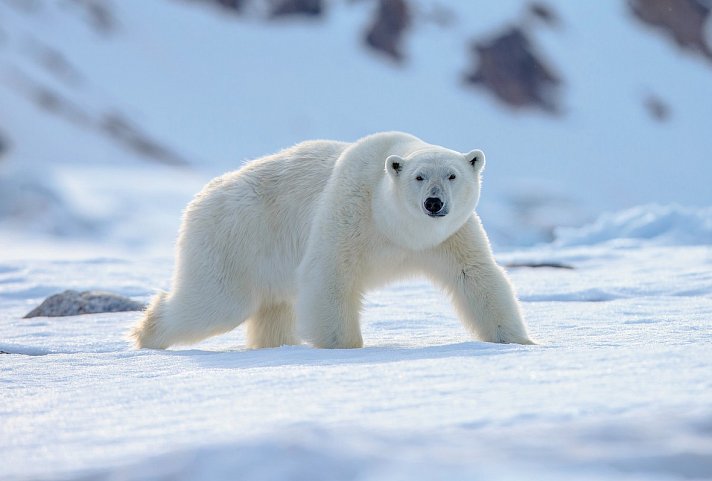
130, 132, 532, 349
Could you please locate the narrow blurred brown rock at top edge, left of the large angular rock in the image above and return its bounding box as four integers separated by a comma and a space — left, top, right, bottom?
365, 0, 410, 60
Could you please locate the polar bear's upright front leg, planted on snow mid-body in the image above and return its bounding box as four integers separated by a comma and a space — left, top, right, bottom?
296, 252, 363, 349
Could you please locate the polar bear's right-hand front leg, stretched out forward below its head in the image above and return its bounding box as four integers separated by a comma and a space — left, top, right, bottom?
428, 216, 534, 344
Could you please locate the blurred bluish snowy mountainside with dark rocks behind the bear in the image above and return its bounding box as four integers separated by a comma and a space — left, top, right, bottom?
0, 0, 712, 249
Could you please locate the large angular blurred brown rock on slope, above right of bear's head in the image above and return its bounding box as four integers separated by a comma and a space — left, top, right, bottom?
466, 27, 561, 113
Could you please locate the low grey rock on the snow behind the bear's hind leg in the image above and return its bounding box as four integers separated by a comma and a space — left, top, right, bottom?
25, 290, 145, 319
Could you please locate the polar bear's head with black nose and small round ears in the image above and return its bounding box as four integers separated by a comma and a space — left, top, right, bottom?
385, 147, 485, 247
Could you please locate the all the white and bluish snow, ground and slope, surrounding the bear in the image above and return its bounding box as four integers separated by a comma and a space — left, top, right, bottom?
0, 0, 712, 481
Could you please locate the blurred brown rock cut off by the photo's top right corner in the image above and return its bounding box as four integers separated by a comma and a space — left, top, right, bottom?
628, 0, 712, 60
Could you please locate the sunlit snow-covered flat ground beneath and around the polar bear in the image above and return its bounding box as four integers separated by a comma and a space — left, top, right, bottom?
0, 211, 712, 480
